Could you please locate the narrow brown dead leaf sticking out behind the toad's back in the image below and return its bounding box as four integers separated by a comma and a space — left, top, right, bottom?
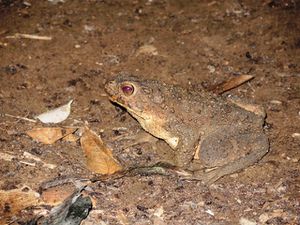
209, 75, 253, 95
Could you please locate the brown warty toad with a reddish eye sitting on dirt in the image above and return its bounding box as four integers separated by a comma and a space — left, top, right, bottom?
105, 75, 269, 184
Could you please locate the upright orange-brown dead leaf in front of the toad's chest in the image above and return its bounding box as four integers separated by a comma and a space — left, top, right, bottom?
80, 128, 122, 174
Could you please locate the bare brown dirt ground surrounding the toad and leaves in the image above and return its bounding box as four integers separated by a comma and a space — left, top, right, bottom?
0, 0, 300, 225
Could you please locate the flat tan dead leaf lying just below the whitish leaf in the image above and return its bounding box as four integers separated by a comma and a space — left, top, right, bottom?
26, 127, 76, 145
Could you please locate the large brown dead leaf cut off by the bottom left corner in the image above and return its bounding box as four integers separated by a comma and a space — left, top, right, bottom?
0, 187, 42, 224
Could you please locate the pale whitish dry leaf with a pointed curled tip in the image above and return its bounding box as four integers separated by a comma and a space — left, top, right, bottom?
35, 100, 73, 123
